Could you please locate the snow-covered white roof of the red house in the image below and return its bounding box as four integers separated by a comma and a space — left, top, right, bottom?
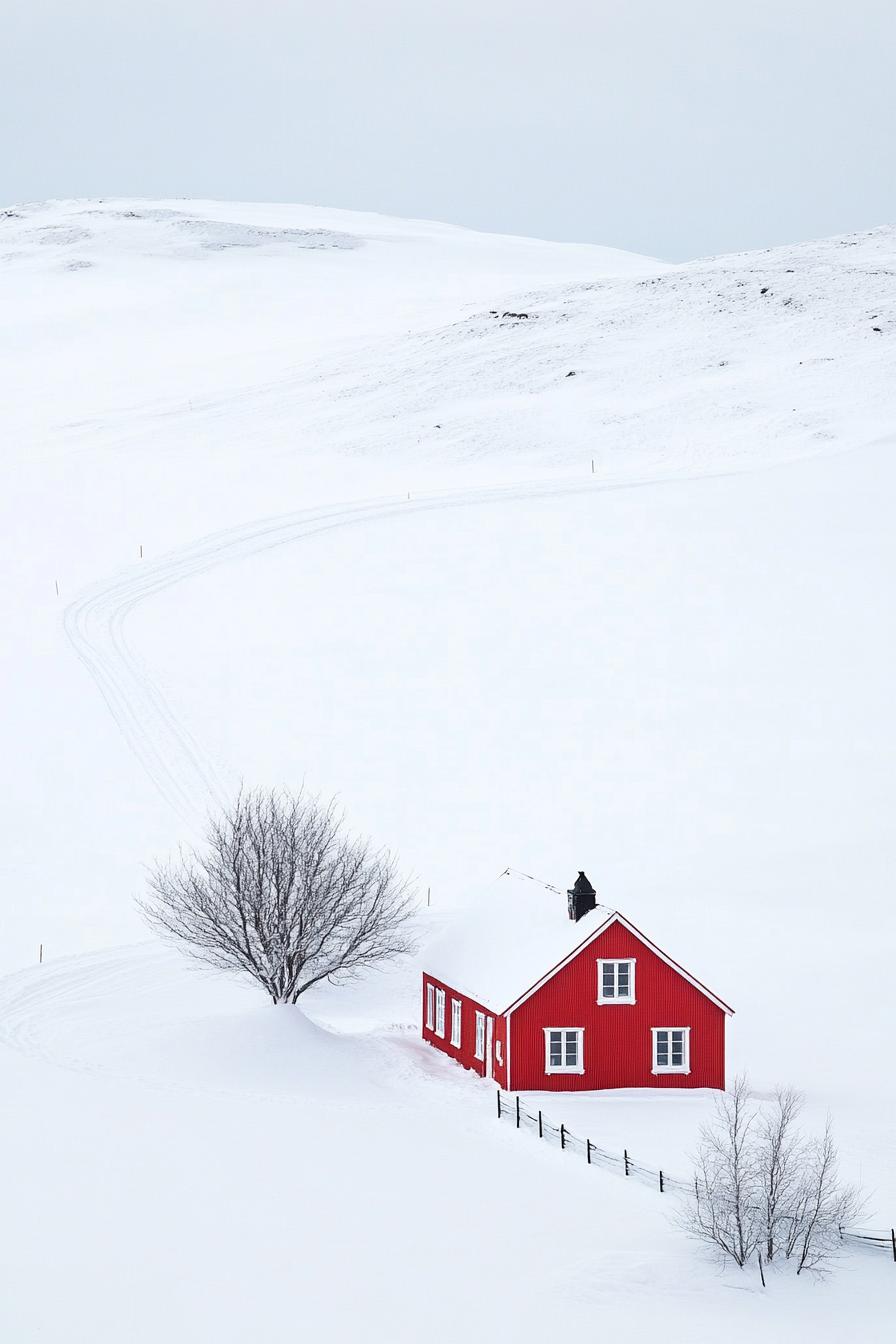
426, 870, 732, 1013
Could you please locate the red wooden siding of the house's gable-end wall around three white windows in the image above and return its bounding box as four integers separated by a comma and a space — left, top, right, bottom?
505, 923, 725, 1091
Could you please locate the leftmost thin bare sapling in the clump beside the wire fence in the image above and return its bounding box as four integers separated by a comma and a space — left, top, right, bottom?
685, 1077, 762, 1266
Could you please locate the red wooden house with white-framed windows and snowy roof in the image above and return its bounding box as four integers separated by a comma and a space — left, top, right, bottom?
423, 872, 733, 1091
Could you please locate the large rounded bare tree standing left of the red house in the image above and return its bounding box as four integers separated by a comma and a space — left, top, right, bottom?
140, 790, 414, 1004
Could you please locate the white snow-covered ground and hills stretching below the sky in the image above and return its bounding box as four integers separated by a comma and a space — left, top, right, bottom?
0, 202, 896, 1344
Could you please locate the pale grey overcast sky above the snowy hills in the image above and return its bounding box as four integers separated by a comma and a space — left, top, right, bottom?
0, 0, 896, 259
